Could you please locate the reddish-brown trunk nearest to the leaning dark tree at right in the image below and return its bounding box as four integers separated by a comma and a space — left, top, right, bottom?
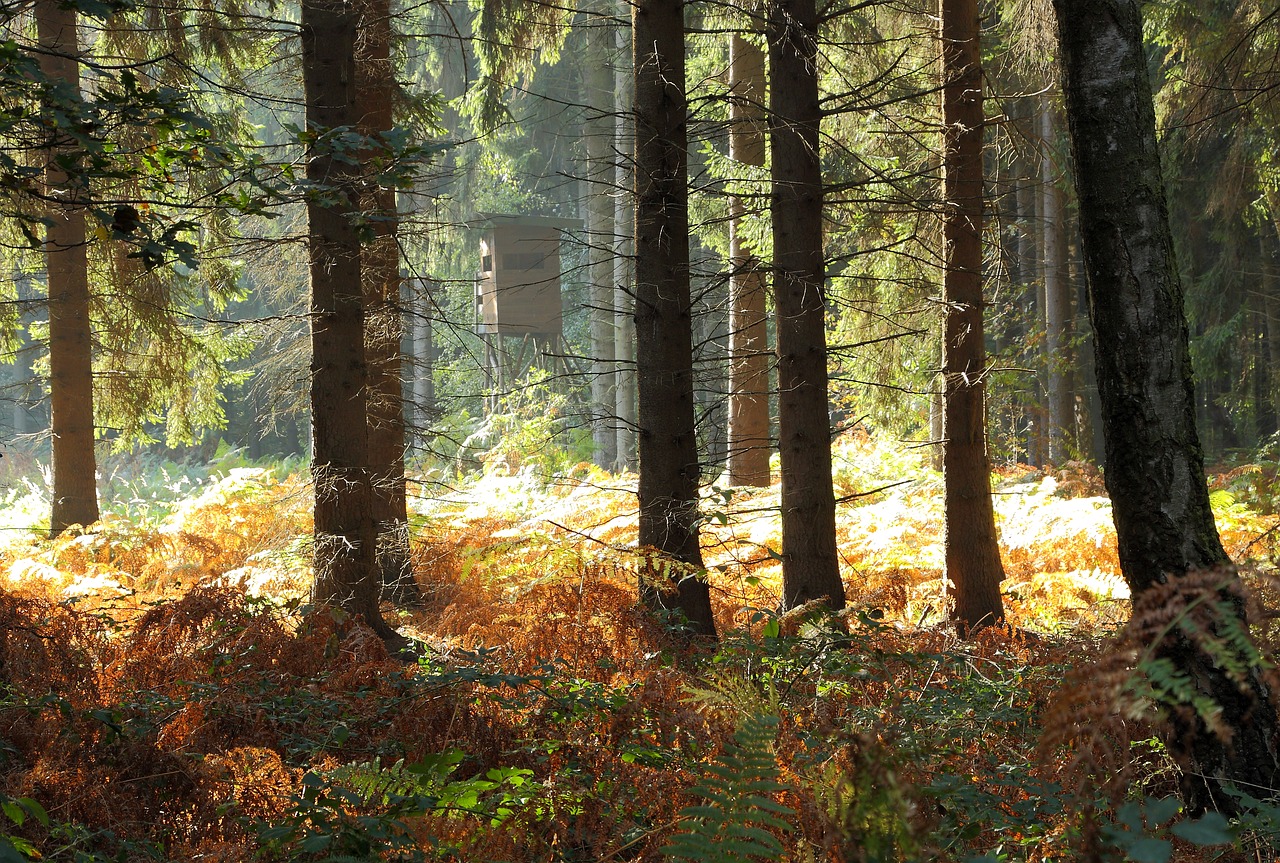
940, 0, 1005, 629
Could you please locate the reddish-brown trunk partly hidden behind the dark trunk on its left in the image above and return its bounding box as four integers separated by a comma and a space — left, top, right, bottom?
356, 0, 421, 602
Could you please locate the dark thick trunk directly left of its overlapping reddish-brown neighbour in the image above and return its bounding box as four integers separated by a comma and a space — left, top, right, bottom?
301, 0, 394, 638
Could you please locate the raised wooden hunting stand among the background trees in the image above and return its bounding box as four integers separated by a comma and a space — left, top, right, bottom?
476, 214, 582, 411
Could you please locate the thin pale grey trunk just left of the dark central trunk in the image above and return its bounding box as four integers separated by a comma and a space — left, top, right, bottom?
613, 15, 637, 470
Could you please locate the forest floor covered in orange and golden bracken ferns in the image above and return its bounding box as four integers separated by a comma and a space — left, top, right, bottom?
0, 434, 1280, 863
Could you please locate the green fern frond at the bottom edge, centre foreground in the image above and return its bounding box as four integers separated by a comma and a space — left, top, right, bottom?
663, 713, 795, 863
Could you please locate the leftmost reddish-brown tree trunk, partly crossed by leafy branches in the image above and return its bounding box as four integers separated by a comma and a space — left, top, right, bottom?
35, 0, 99, 536
